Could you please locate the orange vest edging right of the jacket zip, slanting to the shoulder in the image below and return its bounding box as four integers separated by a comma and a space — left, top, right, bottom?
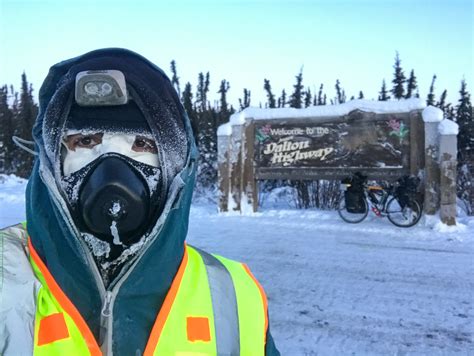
143, 245, 188, 356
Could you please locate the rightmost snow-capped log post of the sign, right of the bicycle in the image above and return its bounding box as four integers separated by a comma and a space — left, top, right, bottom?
438, 119, 459, 225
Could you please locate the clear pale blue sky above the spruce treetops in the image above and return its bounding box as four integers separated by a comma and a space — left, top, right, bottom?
0, 0, 474, 106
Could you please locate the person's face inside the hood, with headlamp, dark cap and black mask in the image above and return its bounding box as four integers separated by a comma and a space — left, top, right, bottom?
60, 70, 164, 246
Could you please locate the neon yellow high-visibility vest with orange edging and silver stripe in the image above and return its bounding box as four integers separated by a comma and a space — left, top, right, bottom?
28, 241, 268, 356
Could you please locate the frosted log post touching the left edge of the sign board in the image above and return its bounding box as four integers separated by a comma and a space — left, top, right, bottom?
240, 120, 258, 213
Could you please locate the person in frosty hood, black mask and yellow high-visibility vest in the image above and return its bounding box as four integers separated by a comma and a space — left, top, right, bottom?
0, 48, 279, 356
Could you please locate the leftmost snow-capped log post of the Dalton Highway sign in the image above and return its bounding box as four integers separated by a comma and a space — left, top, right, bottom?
217, 123, 232, 212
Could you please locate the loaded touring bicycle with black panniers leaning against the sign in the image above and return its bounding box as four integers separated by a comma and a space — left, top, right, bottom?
337, 174, 422, 227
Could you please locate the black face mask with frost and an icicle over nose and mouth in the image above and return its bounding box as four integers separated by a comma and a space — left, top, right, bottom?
61, 153, 163, 246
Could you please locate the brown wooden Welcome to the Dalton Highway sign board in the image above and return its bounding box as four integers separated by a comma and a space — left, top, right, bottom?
254, 113, 410, 179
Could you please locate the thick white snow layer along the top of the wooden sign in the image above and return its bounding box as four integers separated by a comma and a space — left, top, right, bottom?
218, 98, 426, 135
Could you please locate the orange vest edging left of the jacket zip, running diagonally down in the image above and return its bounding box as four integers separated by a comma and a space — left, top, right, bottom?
28, 237, 102, 356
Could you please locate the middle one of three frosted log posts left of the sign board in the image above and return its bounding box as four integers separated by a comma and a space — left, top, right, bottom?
228, 124, 243, 211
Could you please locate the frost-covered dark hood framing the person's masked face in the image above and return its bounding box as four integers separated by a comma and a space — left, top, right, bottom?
34, 50, 191, 281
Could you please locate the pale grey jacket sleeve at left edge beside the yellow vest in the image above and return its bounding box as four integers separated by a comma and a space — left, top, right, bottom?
0, 225, 41, 356
